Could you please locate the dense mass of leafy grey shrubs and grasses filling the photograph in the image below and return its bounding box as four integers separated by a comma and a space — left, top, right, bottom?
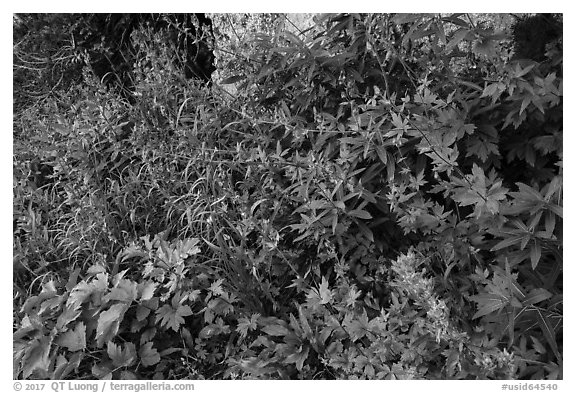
13, 14, 563, 379
